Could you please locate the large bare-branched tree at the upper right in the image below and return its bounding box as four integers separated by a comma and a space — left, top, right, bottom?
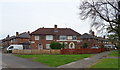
80, 0, 120, 47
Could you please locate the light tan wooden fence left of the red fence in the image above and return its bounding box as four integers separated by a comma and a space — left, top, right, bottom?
12, 49, 61, 54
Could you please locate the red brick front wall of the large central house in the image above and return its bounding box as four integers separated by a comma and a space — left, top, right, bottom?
30, 35, 80, 49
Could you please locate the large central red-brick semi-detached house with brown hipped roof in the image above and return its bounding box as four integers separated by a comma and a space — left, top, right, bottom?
30, 25, 81, 49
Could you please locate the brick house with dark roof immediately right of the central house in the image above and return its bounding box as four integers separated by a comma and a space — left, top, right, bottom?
80, 31, 108, 48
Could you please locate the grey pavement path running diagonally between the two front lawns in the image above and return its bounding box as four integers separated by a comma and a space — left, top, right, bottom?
57, 51, 111, 68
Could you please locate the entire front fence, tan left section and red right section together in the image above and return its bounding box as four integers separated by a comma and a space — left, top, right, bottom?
12, 48, 106, 54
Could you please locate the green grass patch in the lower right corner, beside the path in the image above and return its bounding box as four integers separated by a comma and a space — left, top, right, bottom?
91, 58, 118, 68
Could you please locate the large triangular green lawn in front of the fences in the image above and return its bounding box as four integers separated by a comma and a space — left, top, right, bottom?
16, 54, 92, 67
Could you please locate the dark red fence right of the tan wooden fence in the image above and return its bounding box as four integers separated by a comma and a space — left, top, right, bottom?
61, 48, 106, 54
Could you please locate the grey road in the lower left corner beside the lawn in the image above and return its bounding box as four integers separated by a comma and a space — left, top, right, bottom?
0, 52, 50, 68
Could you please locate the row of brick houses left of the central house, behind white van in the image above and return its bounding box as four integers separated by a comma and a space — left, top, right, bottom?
2, 31, 30, 48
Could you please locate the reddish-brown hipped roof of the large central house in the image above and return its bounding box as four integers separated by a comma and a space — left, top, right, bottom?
31, 28, 81, 36
